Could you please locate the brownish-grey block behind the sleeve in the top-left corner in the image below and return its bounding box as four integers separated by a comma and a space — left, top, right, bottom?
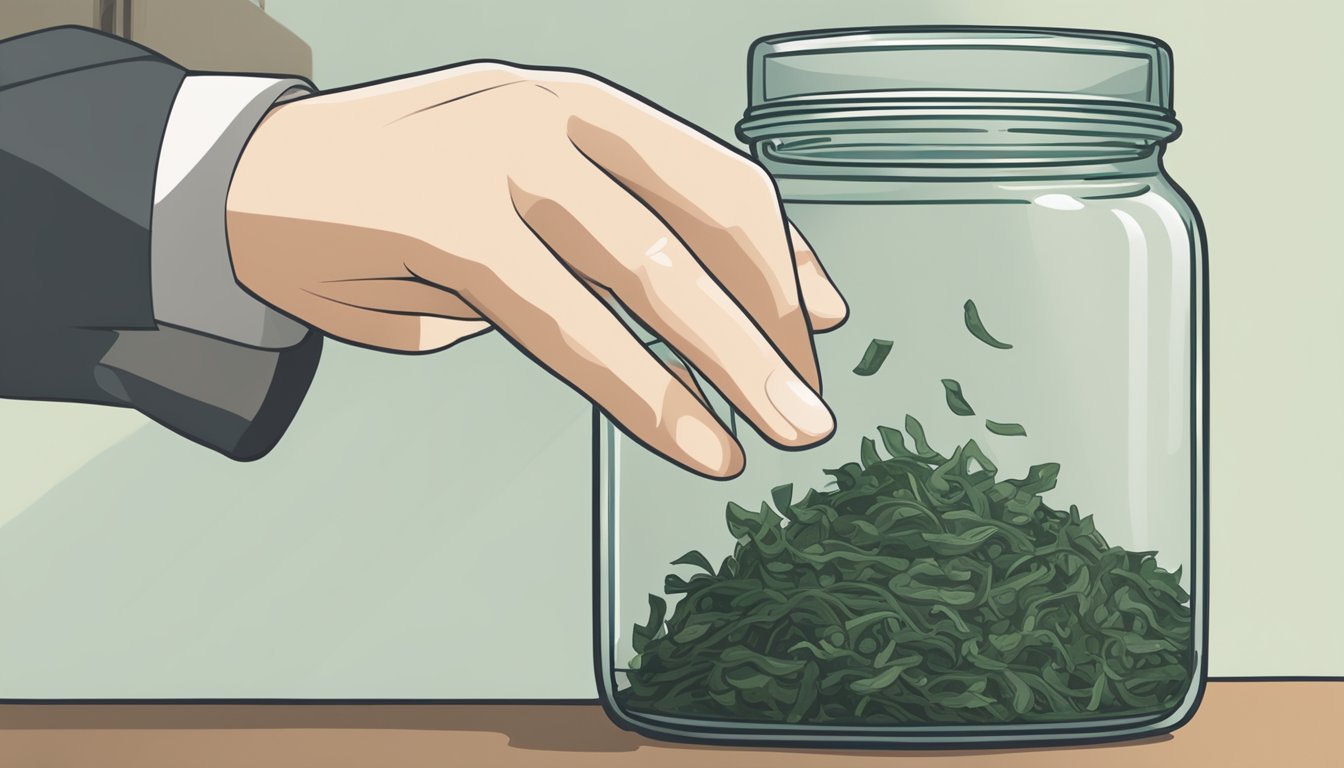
0, 0, 313, 78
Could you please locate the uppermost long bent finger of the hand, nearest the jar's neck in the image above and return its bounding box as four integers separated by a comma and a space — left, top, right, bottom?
570, 91, 820, 389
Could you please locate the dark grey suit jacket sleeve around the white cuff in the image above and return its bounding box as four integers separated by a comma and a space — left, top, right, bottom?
0, 27, 321, 460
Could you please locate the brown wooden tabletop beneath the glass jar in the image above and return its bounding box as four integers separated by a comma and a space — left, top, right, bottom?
0, 681, 1344, 768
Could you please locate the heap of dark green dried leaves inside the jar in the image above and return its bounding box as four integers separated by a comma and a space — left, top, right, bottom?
620, 417, 1191, 725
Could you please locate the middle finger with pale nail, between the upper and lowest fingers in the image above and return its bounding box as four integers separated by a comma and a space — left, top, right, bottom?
515, 162, 835, 447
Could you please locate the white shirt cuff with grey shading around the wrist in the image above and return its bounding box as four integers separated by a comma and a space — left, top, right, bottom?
149, 75, 314, 348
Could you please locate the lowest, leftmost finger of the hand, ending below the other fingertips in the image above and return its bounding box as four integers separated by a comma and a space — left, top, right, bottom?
413, 222, 745, 477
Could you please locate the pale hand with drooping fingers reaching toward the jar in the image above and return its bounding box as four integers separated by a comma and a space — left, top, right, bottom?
227, 63, 847, 476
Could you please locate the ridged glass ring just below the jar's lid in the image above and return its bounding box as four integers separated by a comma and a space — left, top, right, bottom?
737, 90, 1180, 165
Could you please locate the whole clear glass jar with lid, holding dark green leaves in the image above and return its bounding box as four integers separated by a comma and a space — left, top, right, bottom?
595, 27, 1207, 746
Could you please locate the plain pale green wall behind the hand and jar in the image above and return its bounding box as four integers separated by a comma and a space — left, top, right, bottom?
0, 0, 1344, 697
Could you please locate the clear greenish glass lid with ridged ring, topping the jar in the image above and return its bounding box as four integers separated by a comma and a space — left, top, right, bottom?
737, 27, 1180, 164
